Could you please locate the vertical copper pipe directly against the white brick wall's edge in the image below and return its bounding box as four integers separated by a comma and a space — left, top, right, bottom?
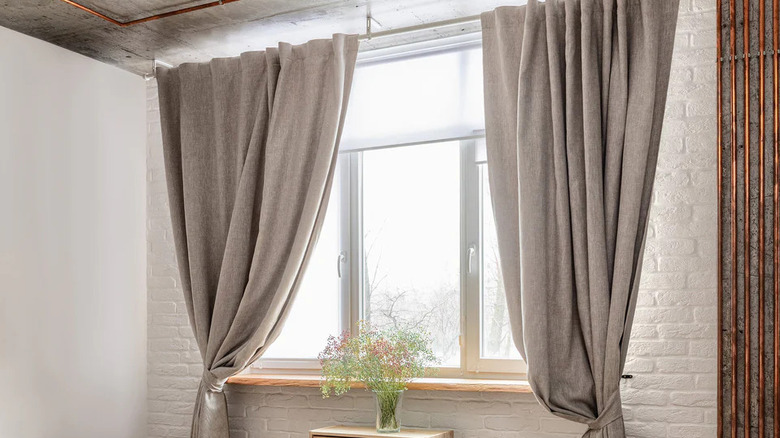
715, 2, 723, 432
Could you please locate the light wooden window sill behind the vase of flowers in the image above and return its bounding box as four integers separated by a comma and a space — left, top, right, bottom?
228, 374, 532, 394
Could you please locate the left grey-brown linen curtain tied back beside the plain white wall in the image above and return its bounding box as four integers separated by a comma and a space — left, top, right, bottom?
157, 35, 358, 438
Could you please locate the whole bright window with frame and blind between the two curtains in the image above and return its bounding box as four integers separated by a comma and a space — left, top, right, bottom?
256, 37, 525, 376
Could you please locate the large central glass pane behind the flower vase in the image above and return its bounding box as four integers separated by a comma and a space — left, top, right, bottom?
363, 143, 460, 366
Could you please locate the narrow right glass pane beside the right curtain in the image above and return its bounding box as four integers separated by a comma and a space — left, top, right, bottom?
479, 164, 520, 359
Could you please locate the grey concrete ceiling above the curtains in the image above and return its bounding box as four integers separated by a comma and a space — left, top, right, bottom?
0, 0, 519, 74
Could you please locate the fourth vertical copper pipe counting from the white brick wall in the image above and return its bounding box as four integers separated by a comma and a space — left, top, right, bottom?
758, 0, 766, 437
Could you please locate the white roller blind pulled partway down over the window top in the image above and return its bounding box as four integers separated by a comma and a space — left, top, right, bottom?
340, 47, 485, 150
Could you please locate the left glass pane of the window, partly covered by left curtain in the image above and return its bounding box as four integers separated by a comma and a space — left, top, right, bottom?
262, 169, 341, 359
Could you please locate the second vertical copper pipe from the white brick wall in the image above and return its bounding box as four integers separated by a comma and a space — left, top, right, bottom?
729, 0, 737, 438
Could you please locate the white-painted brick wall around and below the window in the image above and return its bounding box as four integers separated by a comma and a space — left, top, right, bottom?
147, 0, 717, 438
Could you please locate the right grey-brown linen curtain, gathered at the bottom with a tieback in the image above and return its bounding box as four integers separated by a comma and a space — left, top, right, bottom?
482, 0, 678, 438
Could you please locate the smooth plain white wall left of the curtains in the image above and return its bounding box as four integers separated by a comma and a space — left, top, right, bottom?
0, 27, 146, 438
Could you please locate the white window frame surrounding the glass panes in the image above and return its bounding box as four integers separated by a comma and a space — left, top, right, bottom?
249, 35, 527, 379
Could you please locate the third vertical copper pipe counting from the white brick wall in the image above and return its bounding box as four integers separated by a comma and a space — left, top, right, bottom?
742, 0, 751, 437
